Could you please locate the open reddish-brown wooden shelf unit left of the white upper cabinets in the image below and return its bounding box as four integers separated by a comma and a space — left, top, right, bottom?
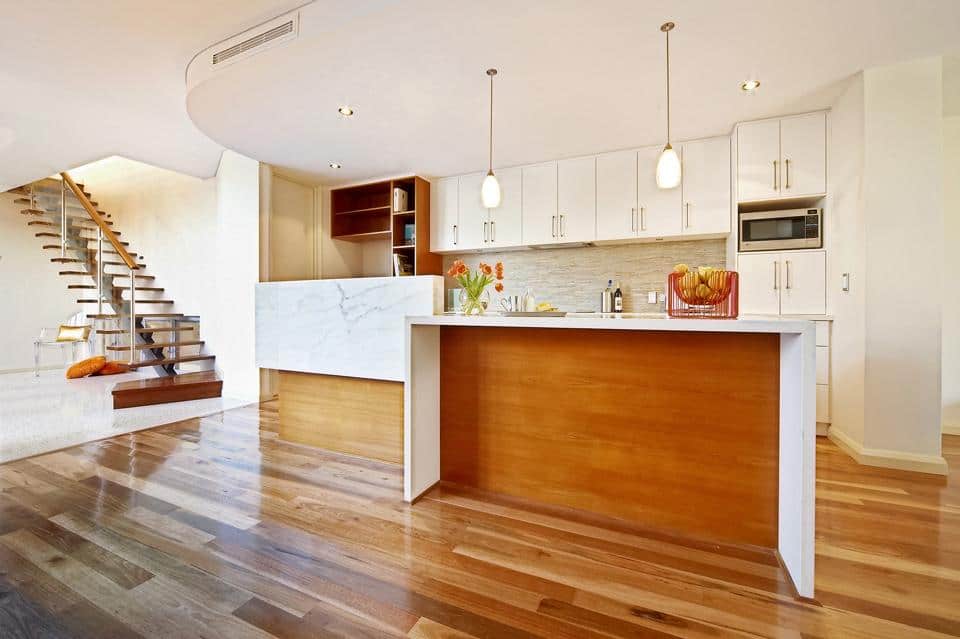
330, 176, 443, 275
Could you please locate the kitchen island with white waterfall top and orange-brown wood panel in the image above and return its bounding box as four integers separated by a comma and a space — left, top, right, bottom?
404, 314, 816, 597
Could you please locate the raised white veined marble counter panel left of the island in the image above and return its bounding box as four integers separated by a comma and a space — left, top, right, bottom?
256, 275, 443, 381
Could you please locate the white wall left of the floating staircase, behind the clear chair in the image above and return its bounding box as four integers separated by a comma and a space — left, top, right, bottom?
0, 193, 81, 373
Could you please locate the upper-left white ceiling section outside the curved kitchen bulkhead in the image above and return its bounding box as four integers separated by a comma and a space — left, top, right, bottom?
0, 0, 300, 191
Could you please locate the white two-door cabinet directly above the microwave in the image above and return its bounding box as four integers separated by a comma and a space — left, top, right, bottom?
737, 112, 827, 202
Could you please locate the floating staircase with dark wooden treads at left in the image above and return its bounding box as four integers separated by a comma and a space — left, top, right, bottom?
11, 173, 222, 408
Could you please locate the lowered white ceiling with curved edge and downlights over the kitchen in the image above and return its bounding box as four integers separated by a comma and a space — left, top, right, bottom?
187, 0, 960, 183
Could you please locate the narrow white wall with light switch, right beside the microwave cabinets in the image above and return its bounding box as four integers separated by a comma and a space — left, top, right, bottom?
826, 74, 866, 443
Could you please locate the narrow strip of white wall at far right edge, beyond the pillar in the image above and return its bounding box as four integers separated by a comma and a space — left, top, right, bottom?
943, 115, 960, 435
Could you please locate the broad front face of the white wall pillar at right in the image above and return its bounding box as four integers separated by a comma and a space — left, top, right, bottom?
863, 57, 943, 456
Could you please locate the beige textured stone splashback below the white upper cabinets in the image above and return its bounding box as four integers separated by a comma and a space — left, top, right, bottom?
443, 240, 726, 313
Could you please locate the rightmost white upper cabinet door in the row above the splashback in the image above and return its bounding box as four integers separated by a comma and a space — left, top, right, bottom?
681, 137, 731, 235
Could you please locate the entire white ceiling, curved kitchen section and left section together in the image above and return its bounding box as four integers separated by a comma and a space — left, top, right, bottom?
0, 0, 960, 188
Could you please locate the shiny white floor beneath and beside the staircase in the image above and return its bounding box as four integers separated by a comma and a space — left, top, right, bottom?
0, 370, 247, 463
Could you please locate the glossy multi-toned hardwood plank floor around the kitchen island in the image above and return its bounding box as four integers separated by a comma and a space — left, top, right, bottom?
0, 403, 960, 639
